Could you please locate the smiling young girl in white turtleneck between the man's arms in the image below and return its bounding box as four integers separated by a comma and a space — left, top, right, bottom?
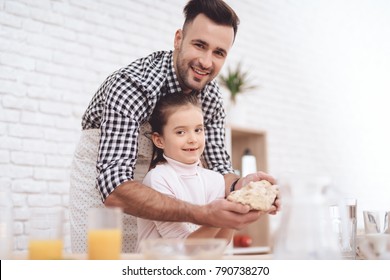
137, 93, 233, 250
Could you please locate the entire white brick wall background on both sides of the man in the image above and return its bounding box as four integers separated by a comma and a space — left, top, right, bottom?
0, 0, 390, 254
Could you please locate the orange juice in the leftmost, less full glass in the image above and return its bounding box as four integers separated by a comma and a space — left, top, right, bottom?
28, 239, 63, 260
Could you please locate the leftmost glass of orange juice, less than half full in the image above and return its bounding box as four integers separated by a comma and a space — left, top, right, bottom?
28, 208, 63, 260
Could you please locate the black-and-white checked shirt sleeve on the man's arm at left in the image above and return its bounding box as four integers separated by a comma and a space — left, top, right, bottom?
97, 71, 149, 200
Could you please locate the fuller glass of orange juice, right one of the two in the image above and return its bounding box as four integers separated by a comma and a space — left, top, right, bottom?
88, 207, 122, 260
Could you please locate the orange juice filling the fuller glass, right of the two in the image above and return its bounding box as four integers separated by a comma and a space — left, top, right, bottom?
88, 229, 122, 260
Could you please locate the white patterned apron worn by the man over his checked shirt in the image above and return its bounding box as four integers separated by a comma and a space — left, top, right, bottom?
69, 123, 153, 253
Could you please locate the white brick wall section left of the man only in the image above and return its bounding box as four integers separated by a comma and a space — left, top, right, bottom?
0, 0, 184, 255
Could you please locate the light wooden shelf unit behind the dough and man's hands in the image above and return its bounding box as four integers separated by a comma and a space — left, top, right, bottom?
226, 126, 270, 246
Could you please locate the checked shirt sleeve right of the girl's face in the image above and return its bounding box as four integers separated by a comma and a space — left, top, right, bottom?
201, 81, 234, 175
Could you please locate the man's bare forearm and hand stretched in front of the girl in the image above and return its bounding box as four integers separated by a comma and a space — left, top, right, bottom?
104, 181, 261, 229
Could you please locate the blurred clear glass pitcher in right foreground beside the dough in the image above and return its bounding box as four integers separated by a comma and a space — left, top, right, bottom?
273, 178, 341, 260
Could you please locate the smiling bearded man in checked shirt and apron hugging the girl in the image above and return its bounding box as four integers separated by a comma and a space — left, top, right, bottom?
70, 0, 279, 252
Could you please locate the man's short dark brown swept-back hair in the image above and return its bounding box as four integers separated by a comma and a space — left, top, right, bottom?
183, 0, 240, 38
